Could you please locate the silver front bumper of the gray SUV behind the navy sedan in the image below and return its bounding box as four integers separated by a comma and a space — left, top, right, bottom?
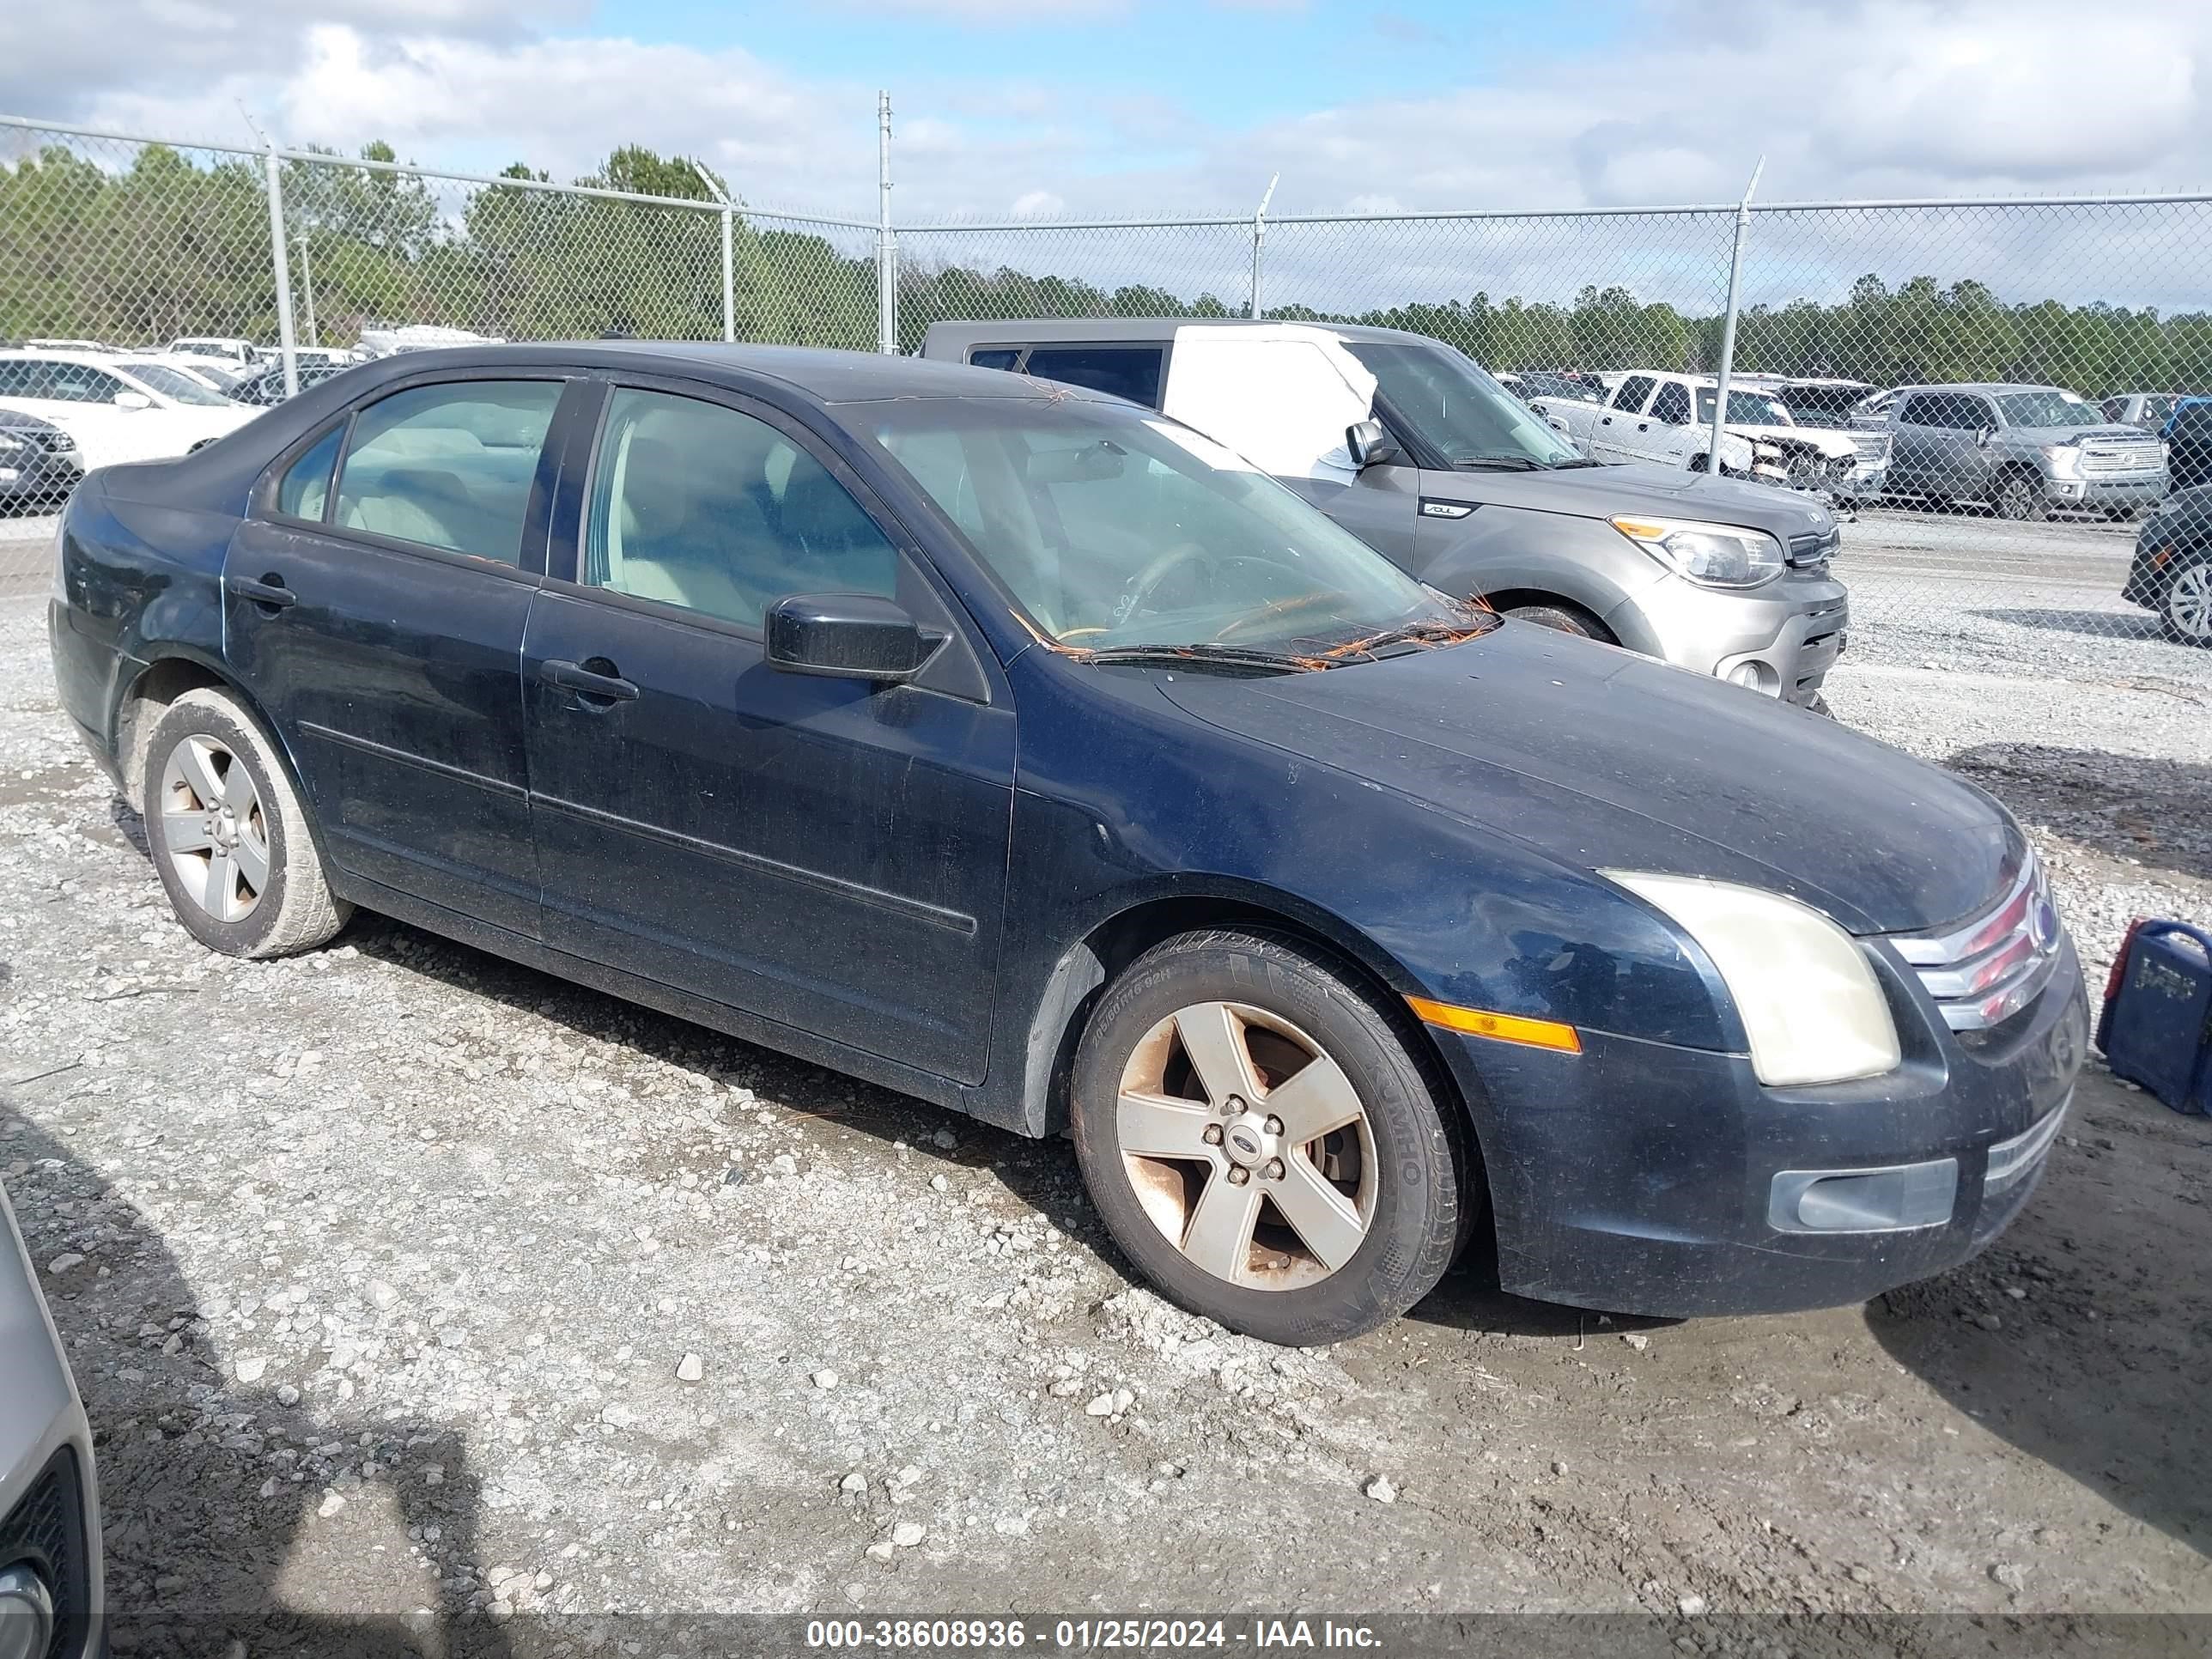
1606, 568, 1851, 706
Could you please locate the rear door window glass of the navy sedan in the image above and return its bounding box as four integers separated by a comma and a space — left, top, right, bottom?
337, 380, 562, 564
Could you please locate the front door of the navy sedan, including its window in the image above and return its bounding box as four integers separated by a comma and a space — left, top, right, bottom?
522, 385, 1015, 1082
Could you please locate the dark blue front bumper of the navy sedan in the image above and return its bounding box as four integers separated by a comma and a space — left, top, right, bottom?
1449, 942, 2088, 1316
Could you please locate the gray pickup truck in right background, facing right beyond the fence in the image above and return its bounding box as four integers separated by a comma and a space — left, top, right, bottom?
1854, 385, 2166, 520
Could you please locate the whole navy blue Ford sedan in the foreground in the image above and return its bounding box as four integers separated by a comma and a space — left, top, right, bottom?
51, 343, 2086, 1343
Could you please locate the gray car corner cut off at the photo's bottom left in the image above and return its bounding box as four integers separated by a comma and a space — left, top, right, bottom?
0, 1192, 100, 1659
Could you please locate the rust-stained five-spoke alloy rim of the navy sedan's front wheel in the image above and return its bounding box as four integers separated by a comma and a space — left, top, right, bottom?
1115, 1002, 1380, 1290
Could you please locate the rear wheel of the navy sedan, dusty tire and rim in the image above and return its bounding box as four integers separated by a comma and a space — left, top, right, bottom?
142, 688, 352, 957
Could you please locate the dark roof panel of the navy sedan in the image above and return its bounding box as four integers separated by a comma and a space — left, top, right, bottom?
354, 341, 1119, 404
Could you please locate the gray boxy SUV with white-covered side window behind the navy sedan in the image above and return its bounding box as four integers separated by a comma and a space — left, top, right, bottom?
922, 319, 1850, 708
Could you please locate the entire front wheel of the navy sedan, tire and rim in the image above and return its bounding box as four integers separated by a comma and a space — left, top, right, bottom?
1073, 931, 1474, 1347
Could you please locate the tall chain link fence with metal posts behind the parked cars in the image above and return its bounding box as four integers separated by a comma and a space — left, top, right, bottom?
0, 119, 2212, 677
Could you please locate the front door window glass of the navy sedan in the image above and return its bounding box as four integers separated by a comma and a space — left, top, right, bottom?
581, 387, 898, 629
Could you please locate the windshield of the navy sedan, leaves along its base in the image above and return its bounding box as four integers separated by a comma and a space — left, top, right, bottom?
854, 398, 1468, 650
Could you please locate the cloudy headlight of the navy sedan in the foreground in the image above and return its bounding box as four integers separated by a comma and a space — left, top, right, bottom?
1599, 869, 1900, 1086
